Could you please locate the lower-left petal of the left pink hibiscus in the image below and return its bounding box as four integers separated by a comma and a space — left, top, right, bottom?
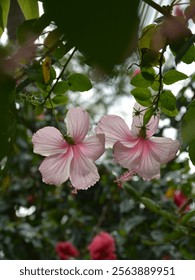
39, 147, 73, 186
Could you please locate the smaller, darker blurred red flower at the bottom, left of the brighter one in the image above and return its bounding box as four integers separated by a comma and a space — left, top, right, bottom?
55, 242, 79, 260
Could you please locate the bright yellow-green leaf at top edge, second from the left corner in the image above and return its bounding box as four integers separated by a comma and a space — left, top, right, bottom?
17, 0, 39, 19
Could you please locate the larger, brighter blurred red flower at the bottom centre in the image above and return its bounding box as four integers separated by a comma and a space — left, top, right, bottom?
88, 232, 116, 260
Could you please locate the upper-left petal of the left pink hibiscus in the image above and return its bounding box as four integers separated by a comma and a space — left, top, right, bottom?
32, 126, 68, 156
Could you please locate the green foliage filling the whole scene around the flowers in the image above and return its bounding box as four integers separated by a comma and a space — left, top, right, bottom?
0, 0, 195, 259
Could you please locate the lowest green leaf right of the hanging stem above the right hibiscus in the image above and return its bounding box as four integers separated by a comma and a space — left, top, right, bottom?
160, 90, 178, 117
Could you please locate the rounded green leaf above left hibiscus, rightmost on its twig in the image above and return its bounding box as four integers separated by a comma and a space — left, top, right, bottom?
68, 73, 92, 91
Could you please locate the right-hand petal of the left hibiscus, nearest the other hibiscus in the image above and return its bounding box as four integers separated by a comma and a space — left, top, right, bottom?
79, 134, 105, 161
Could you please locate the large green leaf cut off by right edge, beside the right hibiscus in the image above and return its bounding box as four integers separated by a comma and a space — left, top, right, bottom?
181, 100, 195, 145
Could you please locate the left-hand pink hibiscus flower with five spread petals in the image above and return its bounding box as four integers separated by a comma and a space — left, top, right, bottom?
32, 107, 105, 190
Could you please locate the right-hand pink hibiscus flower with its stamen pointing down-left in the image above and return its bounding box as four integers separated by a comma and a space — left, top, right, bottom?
96, 103, 179, 182
